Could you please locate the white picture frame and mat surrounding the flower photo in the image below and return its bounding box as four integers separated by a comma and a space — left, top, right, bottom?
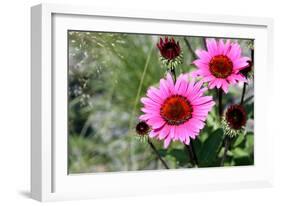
31, 4, 274, 201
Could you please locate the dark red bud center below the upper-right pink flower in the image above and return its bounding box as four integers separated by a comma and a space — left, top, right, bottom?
225, 105, 247, 129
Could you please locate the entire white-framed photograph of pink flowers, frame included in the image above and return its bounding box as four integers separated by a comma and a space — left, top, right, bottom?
31, 4, 273, 201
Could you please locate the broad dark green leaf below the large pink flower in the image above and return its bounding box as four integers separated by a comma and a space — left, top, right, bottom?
198, 129, 224, 167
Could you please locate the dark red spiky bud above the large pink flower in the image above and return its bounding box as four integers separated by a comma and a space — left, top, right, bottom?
157, 37, 181, 60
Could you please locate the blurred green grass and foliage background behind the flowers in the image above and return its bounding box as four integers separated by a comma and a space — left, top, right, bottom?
68, 31, 254, 173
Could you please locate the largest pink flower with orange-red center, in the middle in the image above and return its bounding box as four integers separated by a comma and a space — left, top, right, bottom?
139, 74, 215, 148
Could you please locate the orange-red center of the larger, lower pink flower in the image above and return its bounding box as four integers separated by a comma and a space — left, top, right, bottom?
160, 95, 193, 125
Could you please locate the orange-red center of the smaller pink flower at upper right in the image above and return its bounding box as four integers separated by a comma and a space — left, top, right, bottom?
209, 55, 233, 79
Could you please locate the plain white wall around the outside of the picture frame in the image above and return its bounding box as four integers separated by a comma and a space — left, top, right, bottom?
0, 0, 281, 206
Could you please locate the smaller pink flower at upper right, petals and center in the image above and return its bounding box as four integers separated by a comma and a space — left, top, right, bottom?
193, 39, 250, 93
